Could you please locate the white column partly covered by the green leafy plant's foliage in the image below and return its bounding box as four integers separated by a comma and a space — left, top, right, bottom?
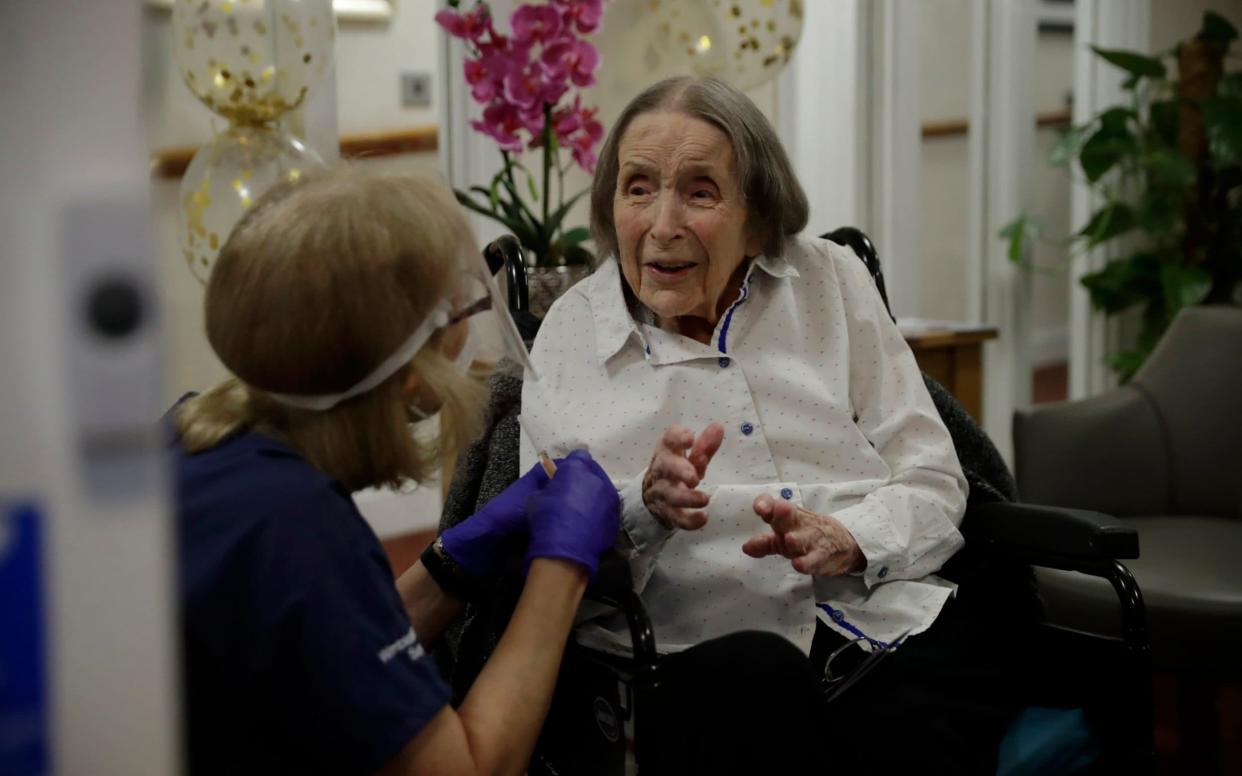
1069, 0, 1151, 399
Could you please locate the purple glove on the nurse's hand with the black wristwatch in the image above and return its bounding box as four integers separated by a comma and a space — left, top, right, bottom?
440, 463, 548, 577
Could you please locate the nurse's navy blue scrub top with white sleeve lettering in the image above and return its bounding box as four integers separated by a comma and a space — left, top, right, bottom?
171, 419, 450, 774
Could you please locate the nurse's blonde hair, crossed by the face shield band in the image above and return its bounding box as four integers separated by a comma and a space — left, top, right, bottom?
176, 165, 486, 490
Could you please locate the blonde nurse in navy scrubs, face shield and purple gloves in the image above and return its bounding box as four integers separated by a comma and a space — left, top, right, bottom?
169, 168, 619, 775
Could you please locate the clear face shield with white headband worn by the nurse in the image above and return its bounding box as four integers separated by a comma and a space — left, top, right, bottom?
271, 242, 535, 415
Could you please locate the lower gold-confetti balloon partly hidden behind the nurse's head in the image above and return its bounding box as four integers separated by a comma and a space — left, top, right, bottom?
178, 127, 323, 283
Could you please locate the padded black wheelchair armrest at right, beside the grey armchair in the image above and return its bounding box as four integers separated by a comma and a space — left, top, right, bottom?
963, 502, 1139, 570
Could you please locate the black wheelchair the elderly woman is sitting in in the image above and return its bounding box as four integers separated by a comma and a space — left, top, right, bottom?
440, 227, 1154, 776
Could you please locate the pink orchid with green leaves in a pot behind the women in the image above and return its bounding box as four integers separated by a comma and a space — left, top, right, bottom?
436, 0, 604, 314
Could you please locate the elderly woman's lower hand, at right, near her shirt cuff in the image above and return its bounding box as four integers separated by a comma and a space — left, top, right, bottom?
741, 494, 867, 576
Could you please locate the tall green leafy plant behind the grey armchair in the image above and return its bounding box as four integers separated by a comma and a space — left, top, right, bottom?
1001, 11, 1242, 380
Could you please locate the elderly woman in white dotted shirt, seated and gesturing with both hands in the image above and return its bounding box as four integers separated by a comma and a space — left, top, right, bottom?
522, 78, 1023, 774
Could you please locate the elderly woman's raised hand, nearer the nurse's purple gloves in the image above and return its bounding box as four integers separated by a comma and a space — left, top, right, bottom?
642, 423, 724, 530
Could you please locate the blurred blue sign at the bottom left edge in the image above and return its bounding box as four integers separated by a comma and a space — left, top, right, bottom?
0, 500, 51, 776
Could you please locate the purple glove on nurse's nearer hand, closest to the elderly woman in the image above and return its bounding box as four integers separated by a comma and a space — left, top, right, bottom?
525, 449, 621, 579
